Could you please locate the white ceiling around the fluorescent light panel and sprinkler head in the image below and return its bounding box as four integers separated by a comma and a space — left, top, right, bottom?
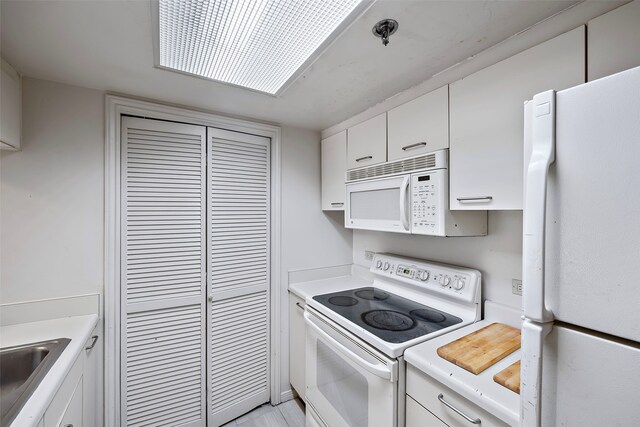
0, 0, 577, 130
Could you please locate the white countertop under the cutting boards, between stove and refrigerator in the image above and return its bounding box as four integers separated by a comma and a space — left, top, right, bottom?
404, 301, 522, 425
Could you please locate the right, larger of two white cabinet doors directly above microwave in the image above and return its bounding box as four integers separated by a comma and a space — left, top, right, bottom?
387, 86, 449, 161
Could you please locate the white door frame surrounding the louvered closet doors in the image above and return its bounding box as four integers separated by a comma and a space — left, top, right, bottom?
104, 95, 281, 426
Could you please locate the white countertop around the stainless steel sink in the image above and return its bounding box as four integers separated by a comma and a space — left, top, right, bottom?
0, 314, 98, 427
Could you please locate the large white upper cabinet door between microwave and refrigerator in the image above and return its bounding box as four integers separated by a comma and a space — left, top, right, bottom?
450, 26, 585, 210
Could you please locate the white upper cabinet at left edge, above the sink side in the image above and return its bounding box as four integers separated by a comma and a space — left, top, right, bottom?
0, 59, 22, 150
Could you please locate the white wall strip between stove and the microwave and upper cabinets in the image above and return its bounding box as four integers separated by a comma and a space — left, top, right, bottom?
353, 211, 522, 308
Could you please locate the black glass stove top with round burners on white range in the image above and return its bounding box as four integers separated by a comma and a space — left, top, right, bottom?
313, 287, 462, 343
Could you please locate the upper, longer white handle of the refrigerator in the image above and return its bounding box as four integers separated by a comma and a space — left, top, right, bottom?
522, 90, 555, 323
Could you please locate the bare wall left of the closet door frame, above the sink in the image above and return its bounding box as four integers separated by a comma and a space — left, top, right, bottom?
0, 78, 104, 304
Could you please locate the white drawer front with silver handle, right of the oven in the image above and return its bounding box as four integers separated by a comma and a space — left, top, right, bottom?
407, 364, 508, 427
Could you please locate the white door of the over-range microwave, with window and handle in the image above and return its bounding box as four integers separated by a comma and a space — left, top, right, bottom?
345, 175, 411, 233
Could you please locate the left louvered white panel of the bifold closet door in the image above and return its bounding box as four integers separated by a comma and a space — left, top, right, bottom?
120, 117, 206, 427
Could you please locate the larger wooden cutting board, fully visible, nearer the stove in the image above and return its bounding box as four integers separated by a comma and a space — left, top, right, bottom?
438, 323, 520, 375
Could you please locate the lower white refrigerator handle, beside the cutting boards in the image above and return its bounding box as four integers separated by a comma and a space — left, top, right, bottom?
520, 319, 553, 427
